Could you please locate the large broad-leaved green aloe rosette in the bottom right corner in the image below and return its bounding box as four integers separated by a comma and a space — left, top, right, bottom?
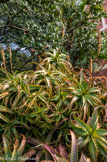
71, 110, 107, 161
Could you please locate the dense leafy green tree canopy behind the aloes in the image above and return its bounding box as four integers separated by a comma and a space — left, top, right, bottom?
0, 0, 107, 67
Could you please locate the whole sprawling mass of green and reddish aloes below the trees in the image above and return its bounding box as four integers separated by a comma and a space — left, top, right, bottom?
0, 50, 107, 162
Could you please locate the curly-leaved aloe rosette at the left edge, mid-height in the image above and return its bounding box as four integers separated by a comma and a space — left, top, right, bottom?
1, 68, 29, 109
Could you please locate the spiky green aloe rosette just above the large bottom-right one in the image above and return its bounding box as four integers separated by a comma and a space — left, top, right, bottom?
64, 70, 100, 121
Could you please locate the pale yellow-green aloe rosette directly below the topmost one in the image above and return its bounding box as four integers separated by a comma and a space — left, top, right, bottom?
31, 64, 64, 94
